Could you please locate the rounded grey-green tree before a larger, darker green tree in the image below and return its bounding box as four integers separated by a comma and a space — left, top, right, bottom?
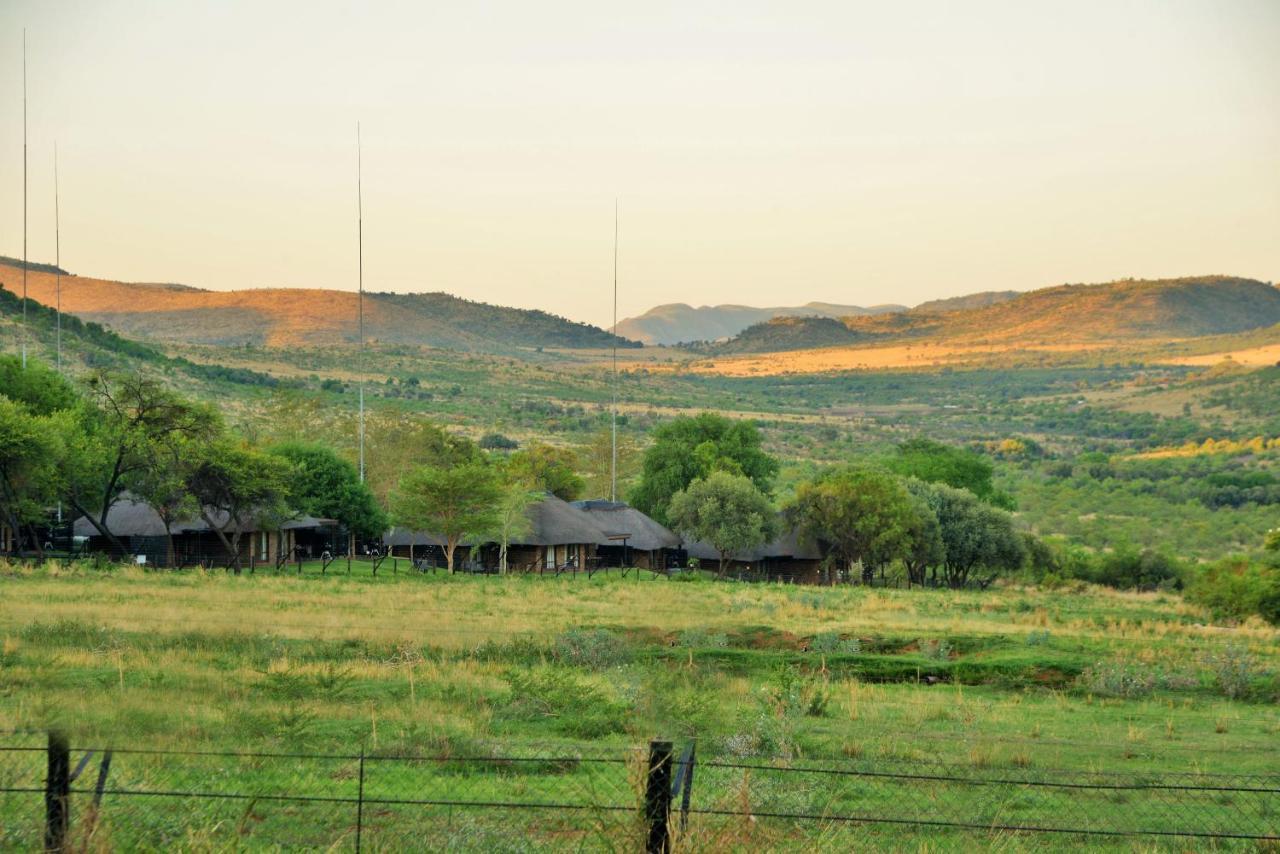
667, 471, 777, 575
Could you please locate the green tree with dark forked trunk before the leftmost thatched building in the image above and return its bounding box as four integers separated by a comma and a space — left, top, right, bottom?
187, 439, 292, 575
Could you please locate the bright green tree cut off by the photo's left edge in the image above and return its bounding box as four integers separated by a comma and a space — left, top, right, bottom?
0, 397, 69, 553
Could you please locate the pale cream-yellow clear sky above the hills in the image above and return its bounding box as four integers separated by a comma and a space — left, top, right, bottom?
0, 0, 1280, 325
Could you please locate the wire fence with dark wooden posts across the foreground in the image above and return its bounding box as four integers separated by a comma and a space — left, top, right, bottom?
0, 736, 1280, 851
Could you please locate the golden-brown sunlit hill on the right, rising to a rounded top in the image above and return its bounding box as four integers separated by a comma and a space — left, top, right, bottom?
714, 275, 1280, 355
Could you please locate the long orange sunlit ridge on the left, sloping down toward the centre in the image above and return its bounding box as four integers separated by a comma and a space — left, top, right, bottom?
0, 259, 637, 352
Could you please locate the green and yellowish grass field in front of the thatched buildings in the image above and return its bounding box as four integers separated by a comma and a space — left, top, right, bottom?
0, 563, 1280, 850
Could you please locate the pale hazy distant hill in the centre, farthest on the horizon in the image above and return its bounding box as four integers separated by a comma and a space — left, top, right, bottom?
617, 302, 906, 344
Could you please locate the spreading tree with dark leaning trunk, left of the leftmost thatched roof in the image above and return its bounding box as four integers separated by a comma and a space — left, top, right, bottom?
61, 374, 219, 554
